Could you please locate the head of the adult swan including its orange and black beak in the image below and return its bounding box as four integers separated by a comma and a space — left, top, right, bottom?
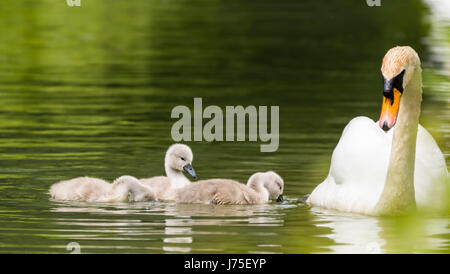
379, 46, 421, 131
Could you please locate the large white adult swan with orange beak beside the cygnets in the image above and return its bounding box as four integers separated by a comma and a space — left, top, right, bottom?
306, 47, 449, 215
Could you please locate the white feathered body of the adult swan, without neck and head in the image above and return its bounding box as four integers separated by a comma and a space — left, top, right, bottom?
307, 116, 448, 214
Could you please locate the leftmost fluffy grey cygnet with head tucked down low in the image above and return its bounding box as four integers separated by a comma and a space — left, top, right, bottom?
50, 175, 156, 202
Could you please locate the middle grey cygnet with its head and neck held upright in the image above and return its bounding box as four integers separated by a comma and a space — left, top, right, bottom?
140, 144, 197, 201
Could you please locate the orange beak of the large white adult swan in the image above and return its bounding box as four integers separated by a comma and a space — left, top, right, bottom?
379, 88, 402, 131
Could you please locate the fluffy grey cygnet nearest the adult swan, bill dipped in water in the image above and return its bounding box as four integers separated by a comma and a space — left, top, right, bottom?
176, 171, 284, 205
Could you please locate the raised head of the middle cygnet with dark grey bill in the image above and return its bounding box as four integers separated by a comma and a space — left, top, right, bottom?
164, 144, 197, 179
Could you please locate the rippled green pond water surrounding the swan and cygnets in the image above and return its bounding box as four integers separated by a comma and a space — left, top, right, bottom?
0, 0, 450, 253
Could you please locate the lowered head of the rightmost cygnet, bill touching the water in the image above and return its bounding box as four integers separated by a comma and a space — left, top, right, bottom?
247, 171, 284, 202
